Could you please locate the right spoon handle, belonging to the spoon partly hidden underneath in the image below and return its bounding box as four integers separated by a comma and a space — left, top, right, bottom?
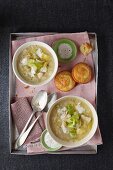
15, 112, 42, 146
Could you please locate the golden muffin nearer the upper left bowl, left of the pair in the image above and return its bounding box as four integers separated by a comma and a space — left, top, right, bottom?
54, 71, 76, 92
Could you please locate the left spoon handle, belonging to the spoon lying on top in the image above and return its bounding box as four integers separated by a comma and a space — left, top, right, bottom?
14, 111, 35, 149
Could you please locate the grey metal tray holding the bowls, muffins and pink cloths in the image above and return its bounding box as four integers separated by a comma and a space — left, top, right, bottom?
9, 32, 98, 155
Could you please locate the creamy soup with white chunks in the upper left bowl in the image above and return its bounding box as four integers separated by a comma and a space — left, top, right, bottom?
17, 45, 54, 84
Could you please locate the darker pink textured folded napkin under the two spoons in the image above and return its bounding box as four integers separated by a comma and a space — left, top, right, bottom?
11, 97, 45, 144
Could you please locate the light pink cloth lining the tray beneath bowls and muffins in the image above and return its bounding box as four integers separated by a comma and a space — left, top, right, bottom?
12, 32, 102, 153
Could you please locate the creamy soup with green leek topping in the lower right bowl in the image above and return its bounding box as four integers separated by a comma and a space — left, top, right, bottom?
49, 98, 93, 141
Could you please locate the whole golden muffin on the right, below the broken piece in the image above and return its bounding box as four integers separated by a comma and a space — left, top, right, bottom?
72, 63, 92, 84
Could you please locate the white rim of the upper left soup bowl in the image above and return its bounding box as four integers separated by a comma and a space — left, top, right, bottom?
12, 41, 58, 86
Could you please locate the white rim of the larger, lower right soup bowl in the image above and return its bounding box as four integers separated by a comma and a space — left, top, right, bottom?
46, 96, 98, 147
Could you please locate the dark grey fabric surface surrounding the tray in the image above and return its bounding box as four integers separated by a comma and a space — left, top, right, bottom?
0, 0, 113, 170
